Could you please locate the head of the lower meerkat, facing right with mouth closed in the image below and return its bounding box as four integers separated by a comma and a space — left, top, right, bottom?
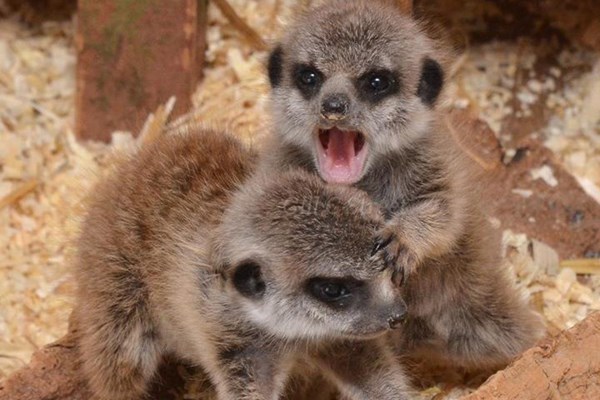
216, 172, 406, 339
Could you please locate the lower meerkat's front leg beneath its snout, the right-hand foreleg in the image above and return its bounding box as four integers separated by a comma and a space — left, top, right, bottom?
315, 338, 411, 400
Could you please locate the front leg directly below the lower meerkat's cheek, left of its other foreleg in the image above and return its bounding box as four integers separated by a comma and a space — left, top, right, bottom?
214, 339, 293, 400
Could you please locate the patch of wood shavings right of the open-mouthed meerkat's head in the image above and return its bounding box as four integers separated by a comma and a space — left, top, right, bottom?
448, 33, 600, 193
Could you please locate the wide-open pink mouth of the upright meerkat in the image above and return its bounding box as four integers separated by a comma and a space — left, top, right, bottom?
316, 127, 367, 184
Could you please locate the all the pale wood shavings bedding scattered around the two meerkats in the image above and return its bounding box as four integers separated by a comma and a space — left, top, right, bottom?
0, 0, 600, 398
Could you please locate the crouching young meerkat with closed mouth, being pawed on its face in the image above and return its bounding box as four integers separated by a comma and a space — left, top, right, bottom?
75, 127, 408, 400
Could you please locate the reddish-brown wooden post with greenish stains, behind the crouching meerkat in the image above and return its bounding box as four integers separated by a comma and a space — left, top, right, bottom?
75, 0, 206, 141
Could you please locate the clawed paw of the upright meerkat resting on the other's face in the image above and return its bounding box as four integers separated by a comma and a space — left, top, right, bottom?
371, 228, 419, 285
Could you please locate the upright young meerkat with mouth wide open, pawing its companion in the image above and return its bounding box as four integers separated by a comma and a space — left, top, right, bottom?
258, 0, 543, 372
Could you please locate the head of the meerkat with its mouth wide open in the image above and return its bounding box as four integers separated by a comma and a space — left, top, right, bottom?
268, 1, 444, 184
